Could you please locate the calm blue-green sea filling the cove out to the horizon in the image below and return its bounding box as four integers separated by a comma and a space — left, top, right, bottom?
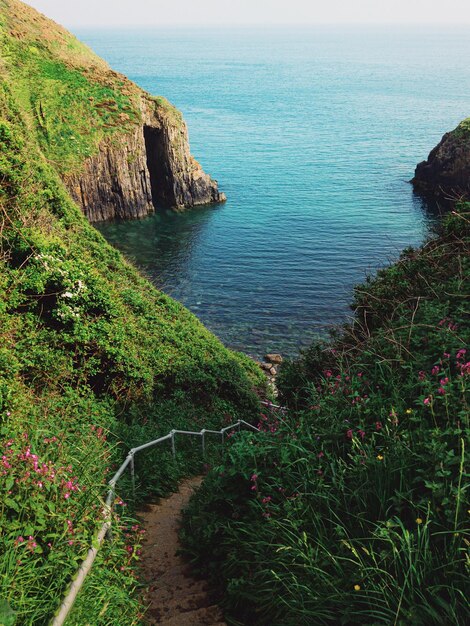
77, 27, 470, 355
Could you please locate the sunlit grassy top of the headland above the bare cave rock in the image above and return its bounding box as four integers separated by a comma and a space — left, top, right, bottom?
0, 0, 182, 175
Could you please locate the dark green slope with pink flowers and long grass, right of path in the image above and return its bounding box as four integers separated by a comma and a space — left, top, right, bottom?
183, 211, 470, 626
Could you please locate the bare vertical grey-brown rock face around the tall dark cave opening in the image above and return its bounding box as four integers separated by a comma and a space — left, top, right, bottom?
65, 93, 226, 222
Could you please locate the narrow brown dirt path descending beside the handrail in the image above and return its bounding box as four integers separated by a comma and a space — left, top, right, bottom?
140, 478, 226, 626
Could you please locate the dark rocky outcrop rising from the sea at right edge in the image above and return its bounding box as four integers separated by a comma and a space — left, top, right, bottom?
412, 118, 470, 198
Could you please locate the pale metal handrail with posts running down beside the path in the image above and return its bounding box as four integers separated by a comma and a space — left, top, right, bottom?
51, 416, 260, 626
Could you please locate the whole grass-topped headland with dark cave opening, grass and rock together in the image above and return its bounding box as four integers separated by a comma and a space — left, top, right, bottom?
0, 0, 225, 222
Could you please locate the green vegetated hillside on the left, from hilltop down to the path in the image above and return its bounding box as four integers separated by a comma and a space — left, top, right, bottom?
0, 0, 262, 626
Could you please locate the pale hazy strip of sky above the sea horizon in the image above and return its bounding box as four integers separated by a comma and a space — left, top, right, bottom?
23, 0, 470, 27
